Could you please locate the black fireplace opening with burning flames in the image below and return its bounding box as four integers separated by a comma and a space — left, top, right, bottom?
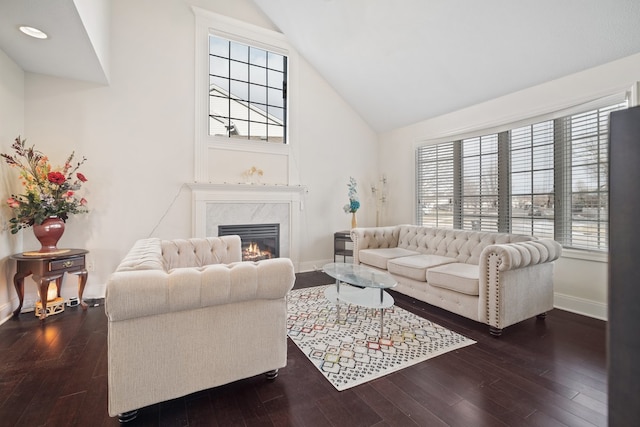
218, 224, 280, 261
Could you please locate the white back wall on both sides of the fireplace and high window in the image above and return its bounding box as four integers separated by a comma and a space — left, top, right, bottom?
0, 0, 377, 312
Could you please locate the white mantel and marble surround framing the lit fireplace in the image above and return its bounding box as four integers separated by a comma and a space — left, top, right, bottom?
189, 183, 306, 272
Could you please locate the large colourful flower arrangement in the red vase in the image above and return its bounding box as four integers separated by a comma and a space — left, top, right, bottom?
0, 136, 88, 234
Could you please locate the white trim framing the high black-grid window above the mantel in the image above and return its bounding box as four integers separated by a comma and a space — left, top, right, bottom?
192, 6, 299, 183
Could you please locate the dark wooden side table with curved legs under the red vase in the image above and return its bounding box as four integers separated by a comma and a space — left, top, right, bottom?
10, 249, 89, 320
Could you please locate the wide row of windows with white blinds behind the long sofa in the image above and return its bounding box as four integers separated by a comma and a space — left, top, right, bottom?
416, 98, 627, 251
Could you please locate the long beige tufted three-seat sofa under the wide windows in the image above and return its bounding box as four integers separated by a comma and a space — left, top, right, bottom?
351, 225, 562, 336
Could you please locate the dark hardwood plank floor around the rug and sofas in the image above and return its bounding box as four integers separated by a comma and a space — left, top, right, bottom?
0, 272, 607, 427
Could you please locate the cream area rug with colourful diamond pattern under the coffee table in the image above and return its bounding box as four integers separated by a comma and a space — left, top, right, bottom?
287, 285, 475, 391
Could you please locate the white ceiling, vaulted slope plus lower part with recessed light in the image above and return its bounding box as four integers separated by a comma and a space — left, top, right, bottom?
0, 0, 640, 132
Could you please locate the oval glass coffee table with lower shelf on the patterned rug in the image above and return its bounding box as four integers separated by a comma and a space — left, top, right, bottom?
322, 262, 398, 336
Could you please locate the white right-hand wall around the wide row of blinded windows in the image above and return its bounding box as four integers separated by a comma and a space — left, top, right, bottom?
379, 54, 640, 318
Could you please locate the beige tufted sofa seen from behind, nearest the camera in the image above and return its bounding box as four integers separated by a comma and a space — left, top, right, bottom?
105, 236, 295, 421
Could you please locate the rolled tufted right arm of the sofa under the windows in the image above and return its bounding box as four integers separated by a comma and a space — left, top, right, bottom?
480, 239, 562, 271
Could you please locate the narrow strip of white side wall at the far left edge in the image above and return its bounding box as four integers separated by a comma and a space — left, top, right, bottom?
0, 50, 24, 322
